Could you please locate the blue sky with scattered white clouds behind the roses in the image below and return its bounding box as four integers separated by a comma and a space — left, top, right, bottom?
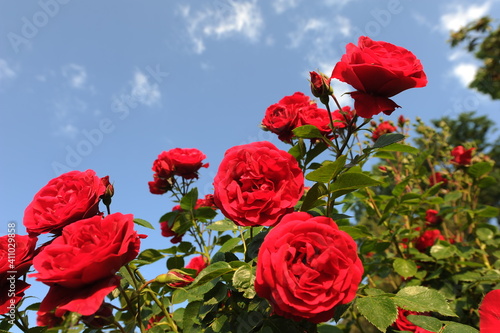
0, 0, 500, 326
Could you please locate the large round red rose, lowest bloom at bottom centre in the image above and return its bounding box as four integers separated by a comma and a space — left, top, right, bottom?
255, 212, 363, 323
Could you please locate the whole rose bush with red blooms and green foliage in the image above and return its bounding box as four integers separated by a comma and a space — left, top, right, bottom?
0, 37, 500, 333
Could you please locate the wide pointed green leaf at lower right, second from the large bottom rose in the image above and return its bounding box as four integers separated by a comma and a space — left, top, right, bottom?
394, 286, 458, 317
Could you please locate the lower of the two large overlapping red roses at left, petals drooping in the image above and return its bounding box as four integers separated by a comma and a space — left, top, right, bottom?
30, 213, 145, 317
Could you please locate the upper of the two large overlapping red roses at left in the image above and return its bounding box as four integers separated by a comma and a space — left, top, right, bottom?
23, 170, 106, 235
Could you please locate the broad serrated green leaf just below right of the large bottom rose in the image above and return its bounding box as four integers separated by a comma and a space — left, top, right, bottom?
356, 296, 398, 332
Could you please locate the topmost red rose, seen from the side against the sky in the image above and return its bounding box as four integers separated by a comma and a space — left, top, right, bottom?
332, 36, 427, 118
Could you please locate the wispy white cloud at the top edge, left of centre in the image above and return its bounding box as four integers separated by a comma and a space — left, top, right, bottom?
179, 0, 264, 53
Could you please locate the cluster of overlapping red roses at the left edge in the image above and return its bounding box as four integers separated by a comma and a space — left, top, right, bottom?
4, 170, 145, 326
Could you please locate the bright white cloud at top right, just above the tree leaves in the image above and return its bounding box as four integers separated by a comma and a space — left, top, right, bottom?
440, 1, 491, 33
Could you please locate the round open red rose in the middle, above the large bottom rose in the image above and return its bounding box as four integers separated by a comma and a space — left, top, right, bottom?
214, 141, 304, 226
